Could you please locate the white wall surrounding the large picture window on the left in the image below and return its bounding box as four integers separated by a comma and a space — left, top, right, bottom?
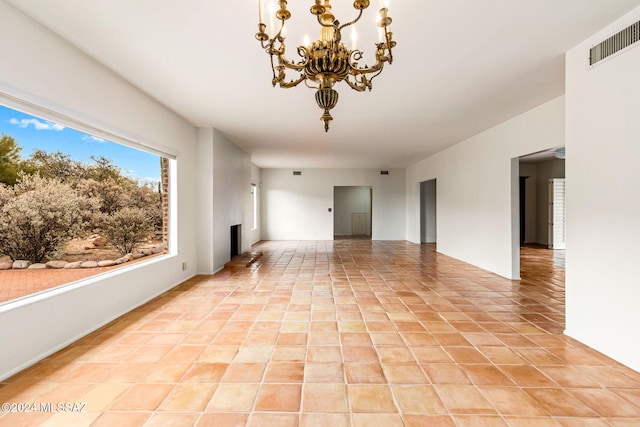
0, 1, 197, 378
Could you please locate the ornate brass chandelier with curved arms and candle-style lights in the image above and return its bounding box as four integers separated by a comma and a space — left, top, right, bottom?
256, 0, 396, 132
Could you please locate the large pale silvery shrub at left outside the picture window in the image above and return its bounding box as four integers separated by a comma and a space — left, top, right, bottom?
0, 174, 95, 262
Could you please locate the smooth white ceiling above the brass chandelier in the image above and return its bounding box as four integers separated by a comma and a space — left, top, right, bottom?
4, 0, 640, 168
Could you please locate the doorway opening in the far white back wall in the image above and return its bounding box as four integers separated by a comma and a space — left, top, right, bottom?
333, 186, 373, 240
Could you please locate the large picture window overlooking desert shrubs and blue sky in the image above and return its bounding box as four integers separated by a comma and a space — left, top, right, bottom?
0, 105, 170, 304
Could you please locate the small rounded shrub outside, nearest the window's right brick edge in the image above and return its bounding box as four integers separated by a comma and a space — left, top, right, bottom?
102, 207, 153, 255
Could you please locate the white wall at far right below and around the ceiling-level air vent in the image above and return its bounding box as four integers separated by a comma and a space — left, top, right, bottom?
566, 8, 640, 371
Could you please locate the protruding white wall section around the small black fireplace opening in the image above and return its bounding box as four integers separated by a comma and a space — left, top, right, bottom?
197, 128, 252, 274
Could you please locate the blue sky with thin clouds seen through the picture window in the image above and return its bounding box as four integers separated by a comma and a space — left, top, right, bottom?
0, 105, 160, 182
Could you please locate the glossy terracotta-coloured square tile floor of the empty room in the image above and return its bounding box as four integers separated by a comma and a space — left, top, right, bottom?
0, 240, 640, 427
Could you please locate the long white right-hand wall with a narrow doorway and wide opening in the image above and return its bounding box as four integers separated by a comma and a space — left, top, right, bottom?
406, 97, 564, 278
